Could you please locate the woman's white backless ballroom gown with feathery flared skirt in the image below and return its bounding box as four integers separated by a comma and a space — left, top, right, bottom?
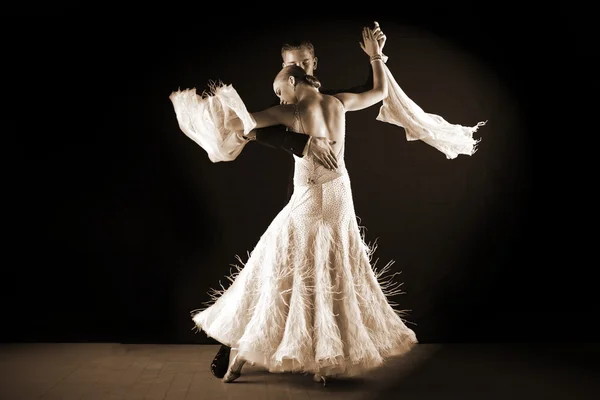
192, 101, 417, 376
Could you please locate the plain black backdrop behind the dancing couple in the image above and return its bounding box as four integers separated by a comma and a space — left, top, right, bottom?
1, 5, 598, 343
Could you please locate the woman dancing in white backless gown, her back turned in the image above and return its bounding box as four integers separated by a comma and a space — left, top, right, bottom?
186, 28, 417, 383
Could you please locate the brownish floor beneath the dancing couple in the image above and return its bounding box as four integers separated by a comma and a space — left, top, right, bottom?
0, 343, 600, 400
